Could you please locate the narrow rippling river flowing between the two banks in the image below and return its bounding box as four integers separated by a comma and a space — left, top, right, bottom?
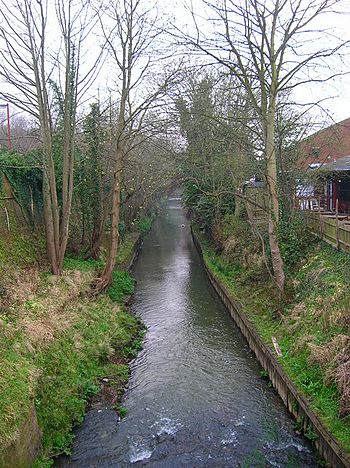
59, 199, 318, 468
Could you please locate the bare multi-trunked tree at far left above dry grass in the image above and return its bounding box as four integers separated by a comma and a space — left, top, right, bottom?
0, 0, 100, 274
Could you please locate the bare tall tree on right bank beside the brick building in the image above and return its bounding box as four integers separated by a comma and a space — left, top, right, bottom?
178, 0, 346, 293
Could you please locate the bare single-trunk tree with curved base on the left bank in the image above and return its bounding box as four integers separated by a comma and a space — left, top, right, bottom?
94, 0, 178, 292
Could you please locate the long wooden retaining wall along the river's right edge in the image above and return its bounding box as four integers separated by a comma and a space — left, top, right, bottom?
192, 231, 350, 468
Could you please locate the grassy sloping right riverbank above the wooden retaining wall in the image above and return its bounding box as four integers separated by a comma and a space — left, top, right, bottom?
191, 226, 350, 464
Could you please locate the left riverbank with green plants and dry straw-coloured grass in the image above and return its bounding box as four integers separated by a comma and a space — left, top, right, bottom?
0, 235, 143, 467
